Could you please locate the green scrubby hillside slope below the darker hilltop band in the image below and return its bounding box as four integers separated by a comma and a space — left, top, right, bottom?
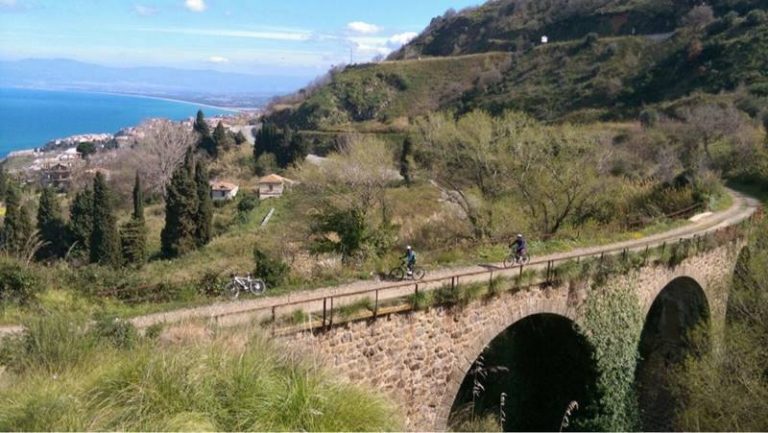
272, 1, 768, 130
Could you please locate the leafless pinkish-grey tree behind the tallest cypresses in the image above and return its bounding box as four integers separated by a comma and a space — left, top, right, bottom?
133, 120, 197, 195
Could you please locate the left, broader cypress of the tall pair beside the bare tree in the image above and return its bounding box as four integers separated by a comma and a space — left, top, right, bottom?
160, 149, 198, 258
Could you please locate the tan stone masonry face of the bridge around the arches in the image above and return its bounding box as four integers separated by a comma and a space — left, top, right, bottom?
281, 244, 740, 430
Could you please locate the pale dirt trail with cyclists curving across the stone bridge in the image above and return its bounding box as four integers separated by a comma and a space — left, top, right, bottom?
0, 190, 760, 335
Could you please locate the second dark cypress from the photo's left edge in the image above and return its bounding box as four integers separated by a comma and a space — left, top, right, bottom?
37, 188, 68, 259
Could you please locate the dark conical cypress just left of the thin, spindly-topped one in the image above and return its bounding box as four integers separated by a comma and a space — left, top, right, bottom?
90, 172, 120, 267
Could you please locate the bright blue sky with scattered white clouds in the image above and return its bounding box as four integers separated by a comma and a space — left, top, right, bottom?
0, 0, 481, 77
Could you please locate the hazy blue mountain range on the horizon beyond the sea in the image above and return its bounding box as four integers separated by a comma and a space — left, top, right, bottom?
0, 59, 308, 96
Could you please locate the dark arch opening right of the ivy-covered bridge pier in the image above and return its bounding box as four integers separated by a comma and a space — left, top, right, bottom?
635, 276, 711, 431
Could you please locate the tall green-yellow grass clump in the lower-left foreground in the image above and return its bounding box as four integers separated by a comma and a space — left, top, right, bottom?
0, 310, 401, 431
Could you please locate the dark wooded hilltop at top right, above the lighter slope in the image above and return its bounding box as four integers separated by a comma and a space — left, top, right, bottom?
390, 0, 768, 60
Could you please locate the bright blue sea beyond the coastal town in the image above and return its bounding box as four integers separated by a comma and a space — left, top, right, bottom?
0, 88, 232, 157
